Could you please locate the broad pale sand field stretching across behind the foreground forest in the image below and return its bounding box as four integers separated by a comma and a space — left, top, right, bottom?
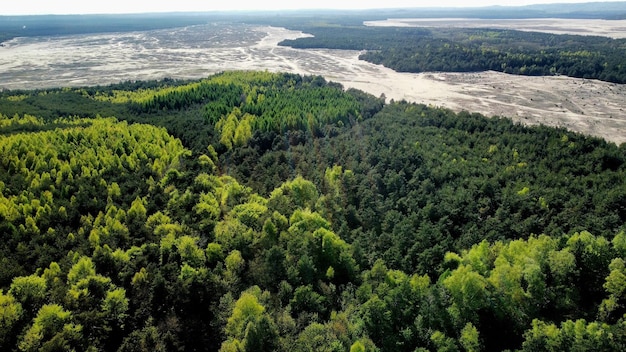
0, 24, 626, 144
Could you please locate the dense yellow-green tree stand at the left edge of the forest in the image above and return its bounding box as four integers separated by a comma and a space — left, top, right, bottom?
0, 115, 186, 239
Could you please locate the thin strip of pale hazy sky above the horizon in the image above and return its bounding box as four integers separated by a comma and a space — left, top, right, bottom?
0, 0, 610, 15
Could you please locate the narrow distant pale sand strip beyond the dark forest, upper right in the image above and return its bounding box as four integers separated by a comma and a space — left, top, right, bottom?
365, 18, 626, 38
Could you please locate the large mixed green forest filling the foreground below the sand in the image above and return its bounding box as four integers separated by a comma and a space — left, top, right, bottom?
0, 72, 626, 352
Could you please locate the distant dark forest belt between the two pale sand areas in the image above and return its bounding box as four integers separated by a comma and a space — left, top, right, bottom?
281, 23, 626, 83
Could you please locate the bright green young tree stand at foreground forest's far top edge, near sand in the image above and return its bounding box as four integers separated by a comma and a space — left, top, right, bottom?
79, 71, 361, 149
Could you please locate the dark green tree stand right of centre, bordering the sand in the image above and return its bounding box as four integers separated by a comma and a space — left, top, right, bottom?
222, 103, 626, 274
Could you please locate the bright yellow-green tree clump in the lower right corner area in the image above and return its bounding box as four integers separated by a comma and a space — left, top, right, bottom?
443, 231, 626, 327
